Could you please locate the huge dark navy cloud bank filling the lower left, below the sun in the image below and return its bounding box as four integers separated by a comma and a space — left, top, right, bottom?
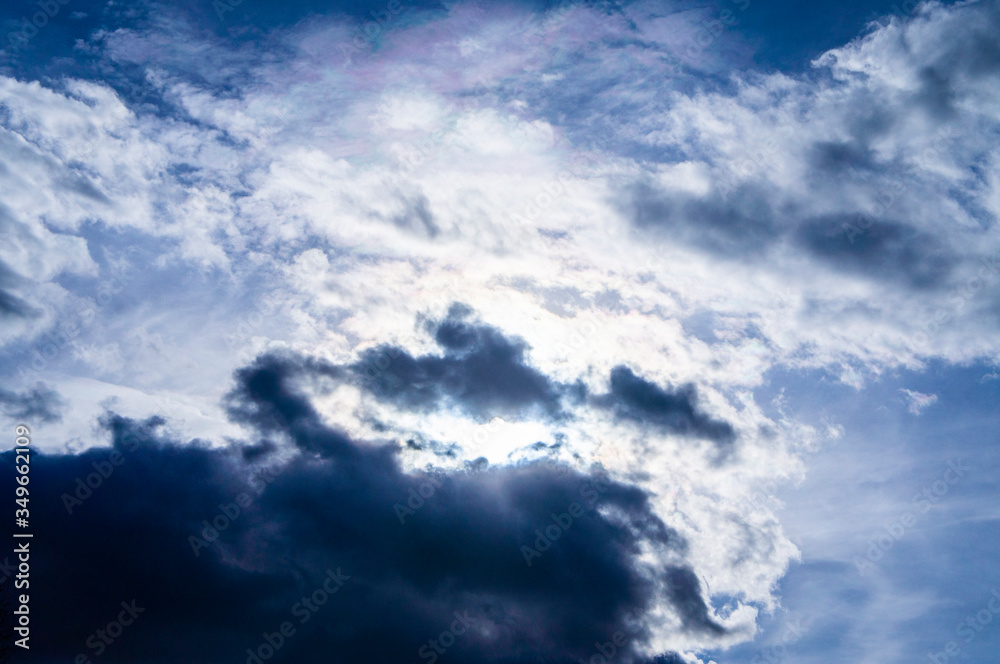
7, 350, 722, 664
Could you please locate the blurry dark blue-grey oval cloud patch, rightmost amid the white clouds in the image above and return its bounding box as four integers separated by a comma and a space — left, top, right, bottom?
797, 215, 956, 289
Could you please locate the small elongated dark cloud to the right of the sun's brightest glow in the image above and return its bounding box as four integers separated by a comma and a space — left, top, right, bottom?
594, 366, 736, 444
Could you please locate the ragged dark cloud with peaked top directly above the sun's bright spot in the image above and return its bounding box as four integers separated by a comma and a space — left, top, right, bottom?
351, 304, 584, 419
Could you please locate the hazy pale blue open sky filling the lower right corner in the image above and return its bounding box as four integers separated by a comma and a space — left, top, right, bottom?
717, 363, 1000, 662
